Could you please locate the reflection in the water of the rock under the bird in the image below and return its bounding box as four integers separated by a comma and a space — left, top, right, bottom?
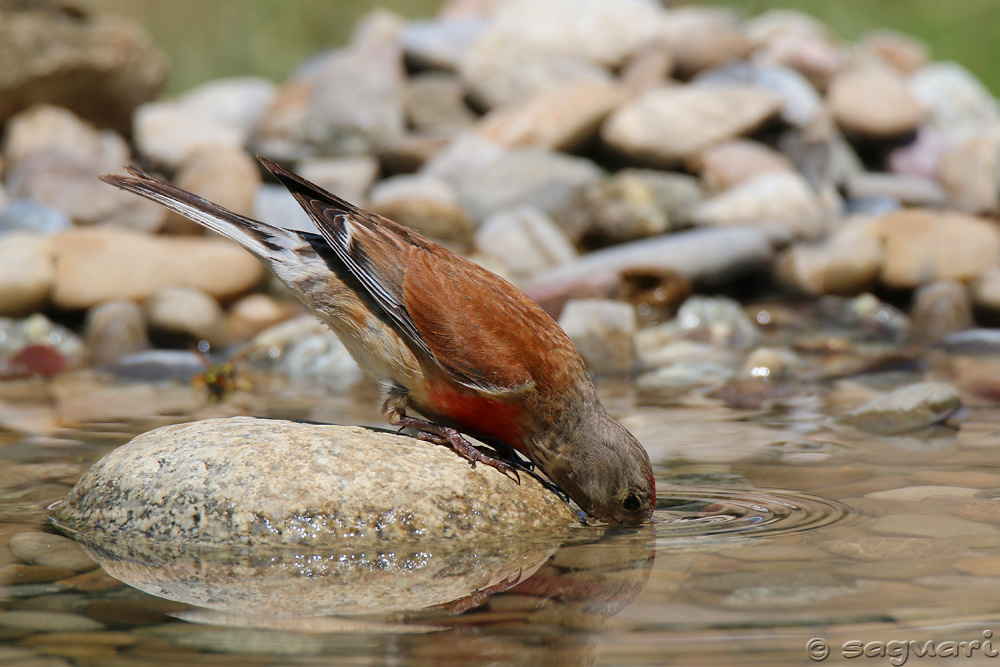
77, 536, 556, 616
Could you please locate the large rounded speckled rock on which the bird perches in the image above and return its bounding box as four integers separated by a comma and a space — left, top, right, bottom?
54, 417, 576, 546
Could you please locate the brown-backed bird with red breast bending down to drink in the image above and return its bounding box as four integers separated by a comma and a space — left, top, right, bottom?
102, 158, 656, 525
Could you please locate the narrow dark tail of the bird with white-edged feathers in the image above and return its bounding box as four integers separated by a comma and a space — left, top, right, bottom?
100, 167, 304, 264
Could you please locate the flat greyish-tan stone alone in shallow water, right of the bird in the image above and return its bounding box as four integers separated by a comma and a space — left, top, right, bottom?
838, 382, 961, 435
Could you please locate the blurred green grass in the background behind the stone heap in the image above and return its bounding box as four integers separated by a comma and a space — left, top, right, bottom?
89, 0, 1000, 94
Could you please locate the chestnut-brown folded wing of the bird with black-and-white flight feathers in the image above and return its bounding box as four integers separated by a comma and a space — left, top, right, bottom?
261, 159, 552, 394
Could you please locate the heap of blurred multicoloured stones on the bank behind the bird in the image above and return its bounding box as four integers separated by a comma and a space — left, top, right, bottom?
0, 0, 1000, 408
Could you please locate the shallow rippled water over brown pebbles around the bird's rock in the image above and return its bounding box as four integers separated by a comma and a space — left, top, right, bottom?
0, 330, 1000, 665
